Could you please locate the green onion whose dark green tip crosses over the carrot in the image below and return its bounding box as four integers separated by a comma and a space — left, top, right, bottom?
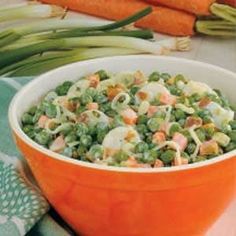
0, 7, 152, 47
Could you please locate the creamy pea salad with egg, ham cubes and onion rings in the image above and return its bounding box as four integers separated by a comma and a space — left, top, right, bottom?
21, 70, 236, 168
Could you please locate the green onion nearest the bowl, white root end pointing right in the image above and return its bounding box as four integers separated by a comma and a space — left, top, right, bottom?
0, 36, 190, 69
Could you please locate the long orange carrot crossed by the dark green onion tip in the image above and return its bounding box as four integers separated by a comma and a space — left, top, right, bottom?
41, 0, 196, 36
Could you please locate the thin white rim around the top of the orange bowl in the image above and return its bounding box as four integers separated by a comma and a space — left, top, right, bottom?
8, 55, 236, 173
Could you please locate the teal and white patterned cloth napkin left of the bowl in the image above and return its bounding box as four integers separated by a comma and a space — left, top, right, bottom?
0, 77, 72, 236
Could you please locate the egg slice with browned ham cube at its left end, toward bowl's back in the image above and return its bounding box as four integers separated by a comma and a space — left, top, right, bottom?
135, 82, 170, 101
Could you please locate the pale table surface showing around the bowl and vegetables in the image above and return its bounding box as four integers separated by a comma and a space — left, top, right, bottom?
0, 0, 236, 236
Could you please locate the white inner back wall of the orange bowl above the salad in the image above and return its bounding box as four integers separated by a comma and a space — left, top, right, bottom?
9, 55, 236, 171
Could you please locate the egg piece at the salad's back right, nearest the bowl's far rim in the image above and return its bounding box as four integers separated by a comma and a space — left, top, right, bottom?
183, 80, 216, 96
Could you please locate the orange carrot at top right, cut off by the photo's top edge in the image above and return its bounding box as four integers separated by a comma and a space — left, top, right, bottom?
145, 0, 215, 15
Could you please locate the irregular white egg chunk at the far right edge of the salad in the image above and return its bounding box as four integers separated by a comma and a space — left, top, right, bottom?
205, 102, 234, 129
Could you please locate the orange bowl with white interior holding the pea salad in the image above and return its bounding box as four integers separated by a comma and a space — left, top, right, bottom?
9, 56, 236, 236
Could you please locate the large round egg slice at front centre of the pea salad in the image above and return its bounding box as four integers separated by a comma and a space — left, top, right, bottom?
102, 126, 141, 150
